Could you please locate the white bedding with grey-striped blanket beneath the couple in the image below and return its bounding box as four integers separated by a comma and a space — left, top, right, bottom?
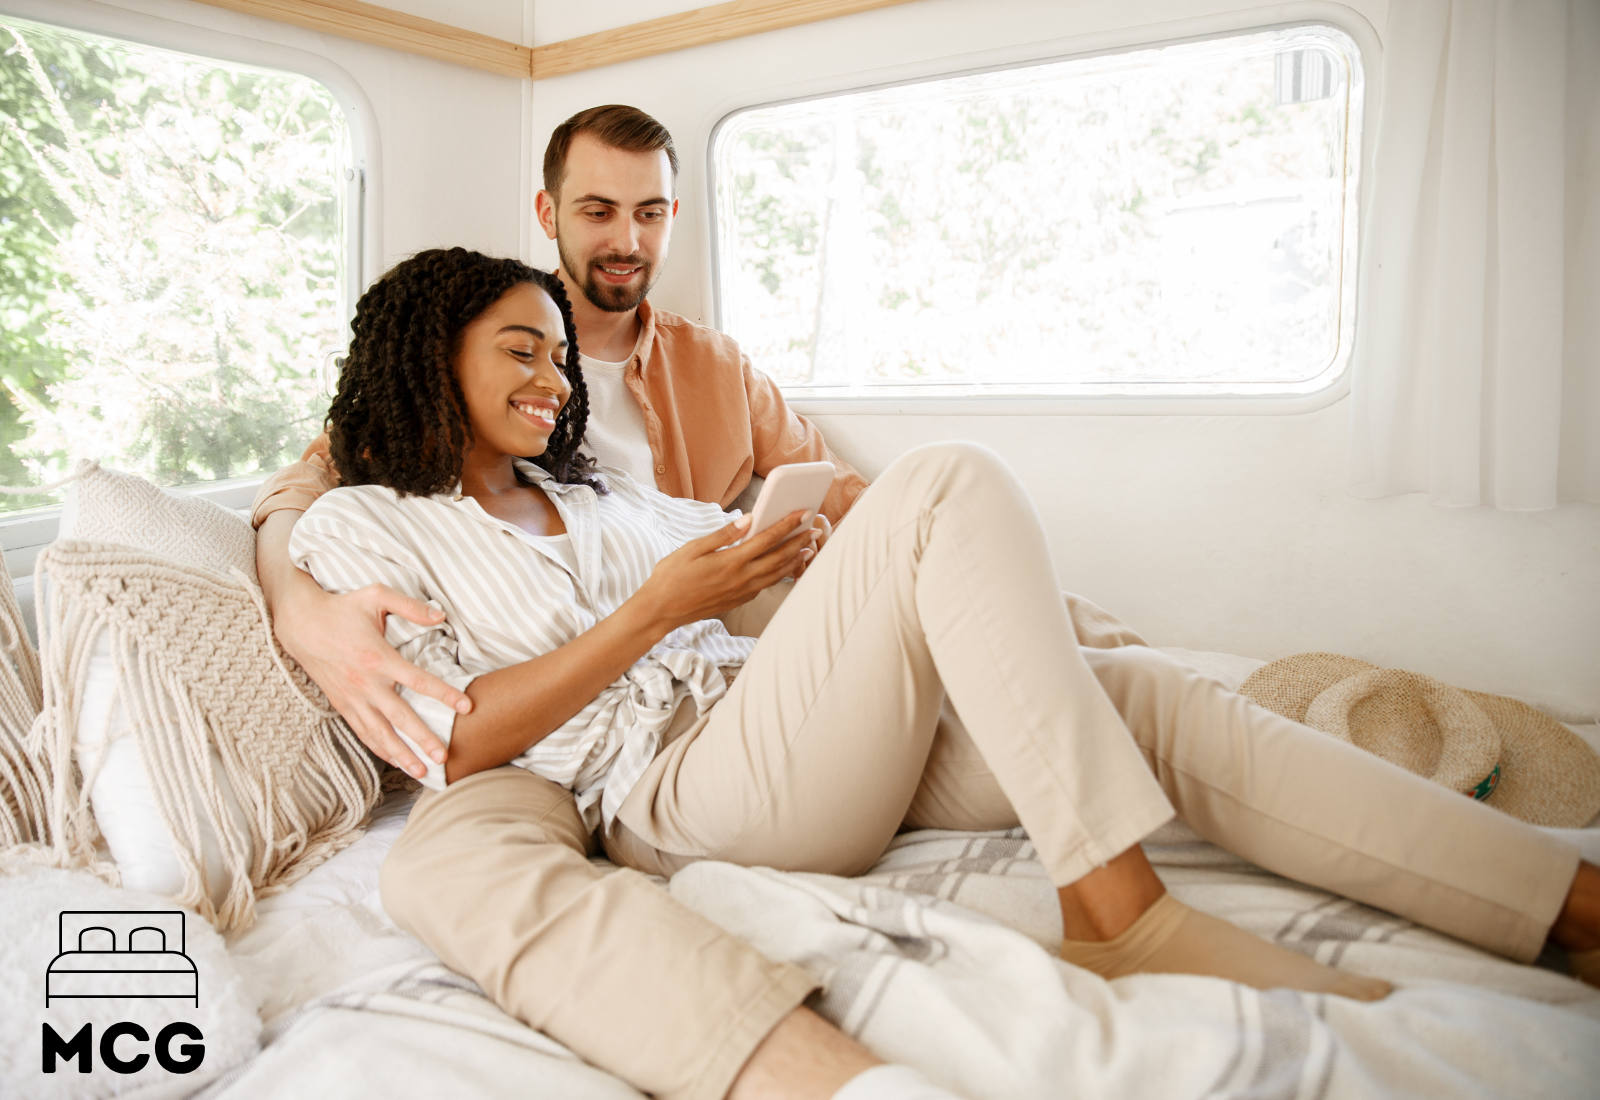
196, 651, 1600, 1100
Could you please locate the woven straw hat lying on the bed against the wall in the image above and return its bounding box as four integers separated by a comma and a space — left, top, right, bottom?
1238, 652, 1600, 828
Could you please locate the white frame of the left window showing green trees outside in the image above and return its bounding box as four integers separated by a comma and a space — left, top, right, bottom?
0, 0, 382, 575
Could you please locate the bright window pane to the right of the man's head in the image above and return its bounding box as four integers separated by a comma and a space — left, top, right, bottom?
710, 26, 1362, 397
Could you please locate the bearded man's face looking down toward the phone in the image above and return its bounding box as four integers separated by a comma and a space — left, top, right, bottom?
538, 134, 678, 313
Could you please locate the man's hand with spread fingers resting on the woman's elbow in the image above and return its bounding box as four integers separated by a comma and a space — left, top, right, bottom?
272, 574, 472, 777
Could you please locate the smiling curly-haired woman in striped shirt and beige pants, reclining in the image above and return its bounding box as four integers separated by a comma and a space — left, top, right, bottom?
291, 249, 1600, 1016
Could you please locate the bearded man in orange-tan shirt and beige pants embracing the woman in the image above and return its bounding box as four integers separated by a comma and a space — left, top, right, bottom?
254, 106, 946, 1100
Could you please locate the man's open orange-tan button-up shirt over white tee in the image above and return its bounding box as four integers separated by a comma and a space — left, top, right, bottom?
251, 302, 867, 526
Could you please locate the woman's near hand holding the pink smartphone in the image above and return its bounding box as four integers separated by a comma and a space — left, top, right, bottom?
632, 512, 826, 636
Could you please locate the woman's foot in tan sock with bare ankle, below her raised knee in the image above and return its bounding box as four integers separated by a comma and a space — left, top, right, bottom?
1061, 846, 1394, 1001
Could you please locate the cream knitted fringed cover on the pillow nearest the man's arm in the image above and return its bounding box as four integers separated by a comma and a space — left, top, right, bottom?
34, 540, 379, 931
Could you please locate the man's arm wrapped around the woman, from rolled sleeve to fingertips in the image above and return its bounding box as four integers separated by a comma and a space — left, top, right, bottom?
253, 436, 472, 777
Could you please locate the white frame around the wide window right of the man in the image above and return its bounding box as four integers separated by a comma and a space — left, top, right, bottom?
704, 12, 1382, 416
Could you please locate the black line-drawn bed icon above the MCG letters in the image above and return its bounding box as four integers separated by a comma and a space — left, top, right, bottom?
45, 910, 200, 1007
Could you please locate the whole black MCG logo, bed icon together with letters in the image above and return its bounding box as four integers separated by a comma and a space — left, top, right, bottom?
40, 910, 205, 1073
